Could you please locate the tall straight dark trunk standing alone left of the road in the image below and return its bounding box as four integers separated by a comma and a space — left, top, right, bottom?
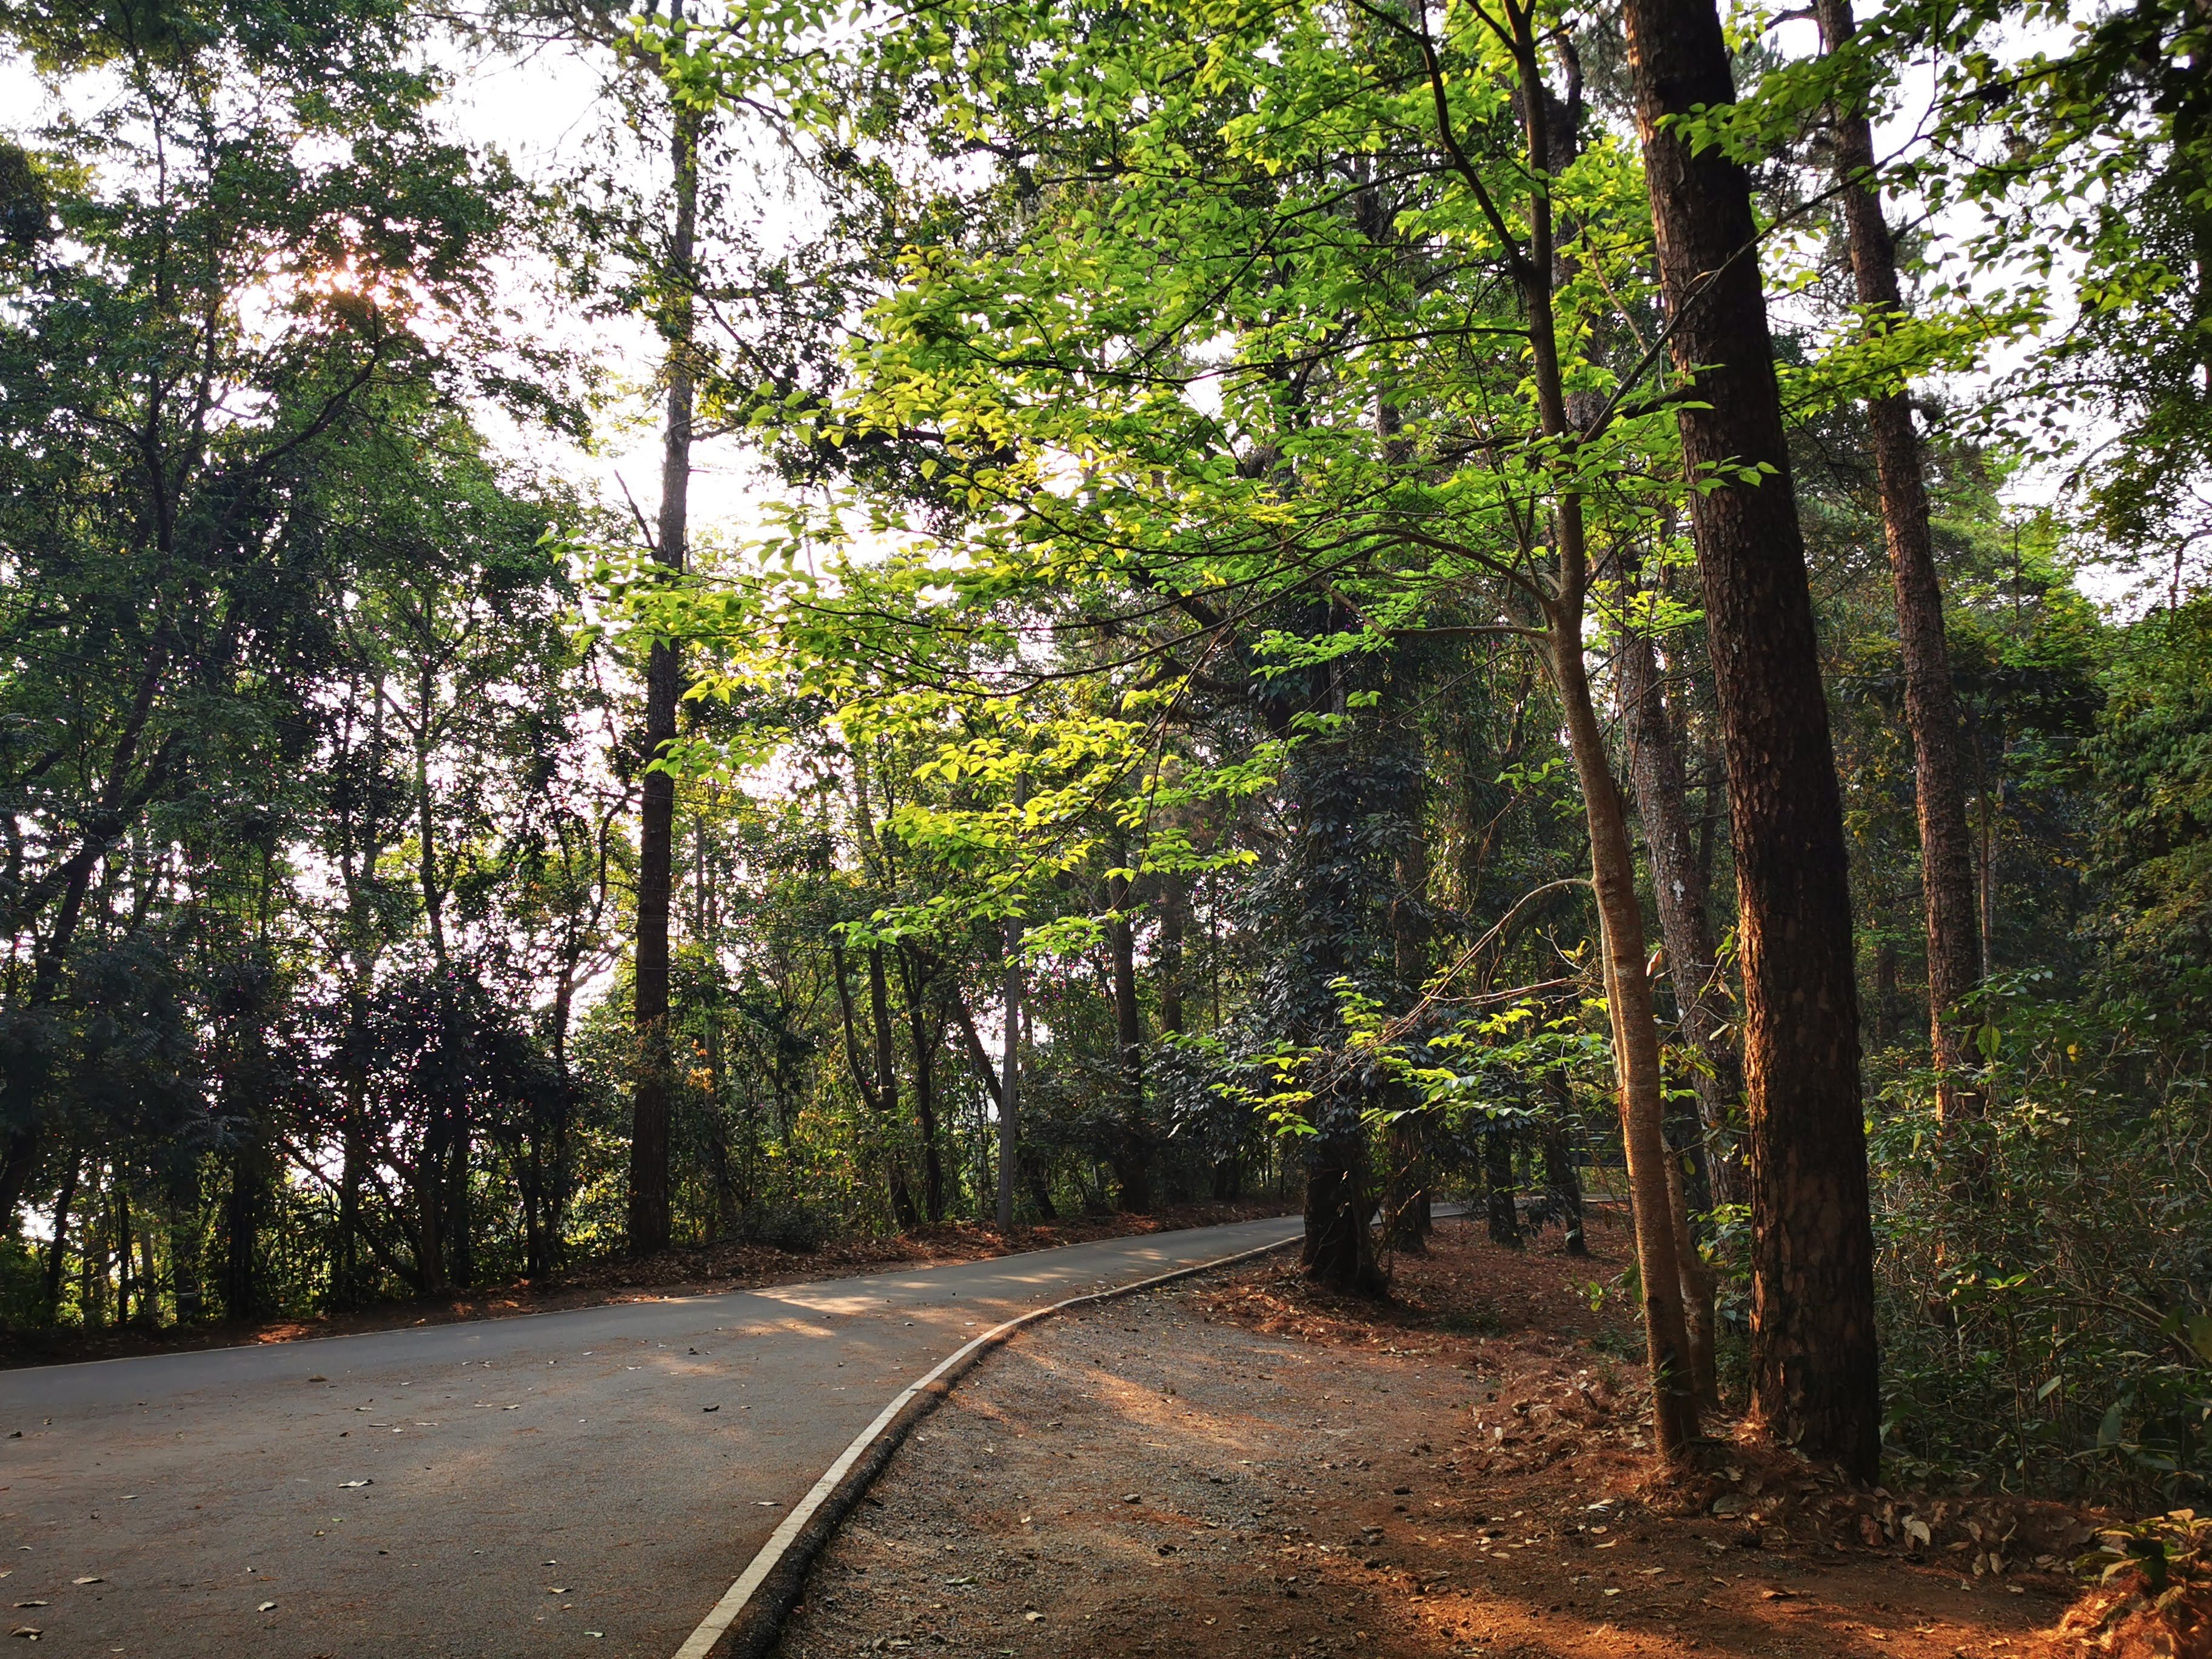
628, 35, 706, 1254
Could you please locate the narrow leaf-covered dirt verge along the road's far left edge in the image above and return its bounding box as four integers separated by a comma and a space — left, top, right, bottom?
0, 1199, 1294, 1369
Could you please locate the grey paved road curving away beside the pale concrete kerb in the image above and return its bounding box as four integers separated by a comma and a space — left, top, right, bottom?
0, 1219, 1298, 1659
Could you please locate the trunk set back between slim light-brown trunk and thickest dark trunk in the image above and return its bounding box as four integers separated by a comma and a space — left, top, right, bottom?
1615, 610, 1750, 1204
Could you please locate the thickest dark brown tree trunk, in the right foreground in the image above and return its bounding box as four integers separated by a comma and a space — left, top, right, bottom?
1624, 0, 1880, 1478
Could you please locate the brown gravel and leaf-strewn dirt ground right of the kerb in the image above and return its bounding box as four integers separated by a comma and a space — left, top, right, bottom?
781, 1221, 2105, 1659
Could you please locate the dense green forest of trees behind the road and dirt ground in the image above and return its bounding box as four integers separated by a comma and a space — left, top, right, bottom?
0, 0, 2212, 1502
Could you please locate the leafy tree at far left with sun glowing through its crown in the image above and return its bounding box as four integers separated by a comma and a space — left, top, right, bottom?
0, 0, 533, 1238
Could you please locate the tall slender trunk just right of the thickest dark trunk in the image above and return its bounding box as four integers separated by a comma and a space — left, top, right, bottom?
1814, 0, 1982, 1122
